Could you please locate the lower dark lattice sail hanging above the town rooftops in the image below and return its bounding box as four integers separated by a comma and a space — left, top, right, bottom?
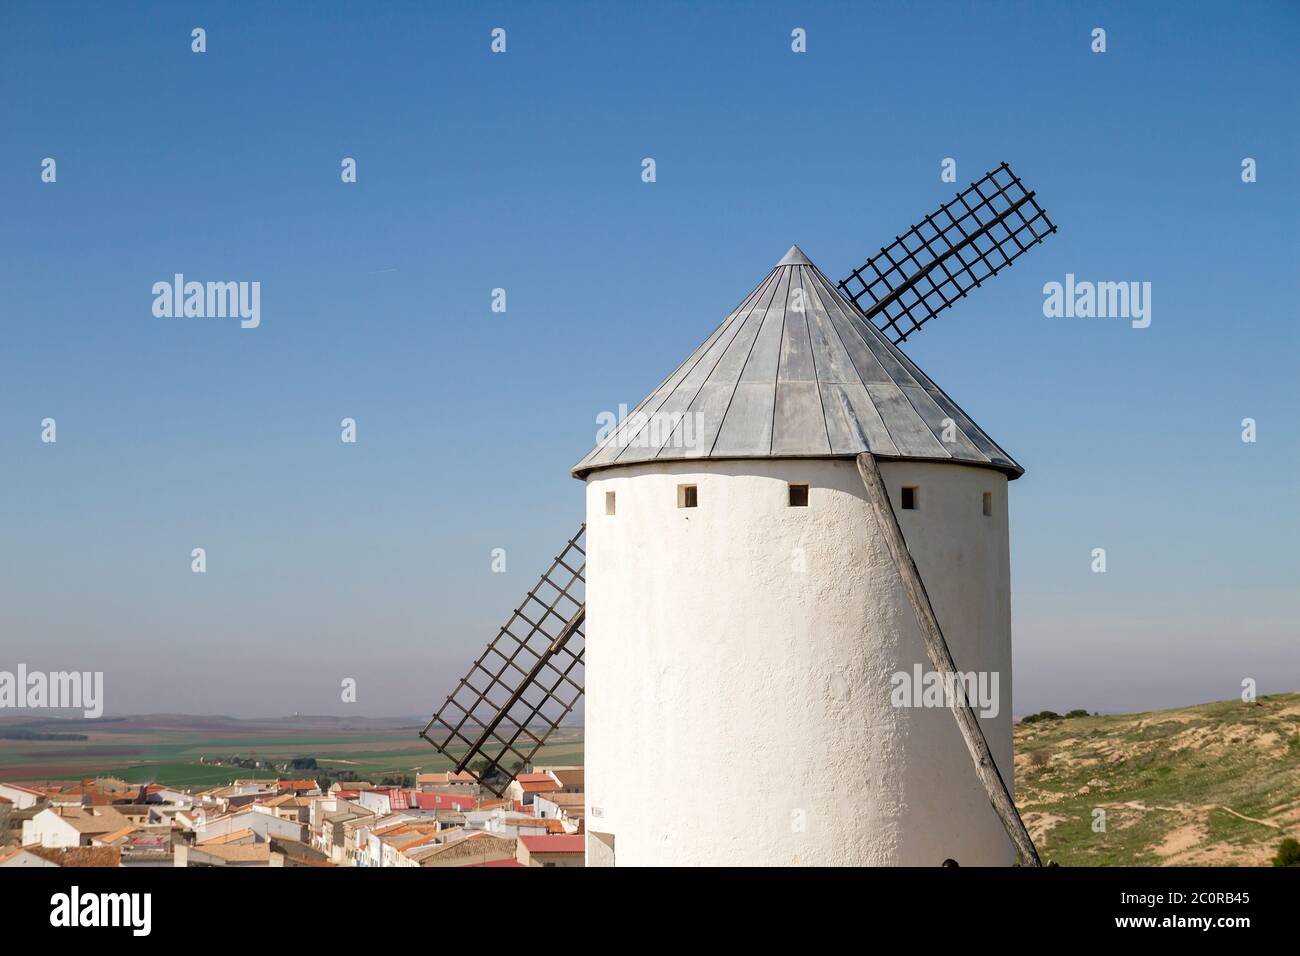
420, 523, 586, 796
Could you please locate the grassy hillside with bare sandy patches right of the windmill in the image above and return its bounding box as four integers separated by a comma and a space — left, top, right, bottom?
1015, 693, 1300, 866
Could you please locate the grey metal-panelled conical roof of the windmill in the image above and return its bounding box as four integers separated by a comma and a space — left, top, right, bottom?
573, 246, 1024, 479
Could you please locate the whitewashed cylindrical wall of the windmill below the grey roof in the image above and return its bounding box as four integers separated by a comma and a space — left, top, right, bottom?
585, 460, 1015, 866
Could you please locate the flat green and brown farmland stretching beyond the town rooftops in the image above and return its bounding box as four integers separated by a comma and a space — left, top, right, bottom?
0, 714, 582, 787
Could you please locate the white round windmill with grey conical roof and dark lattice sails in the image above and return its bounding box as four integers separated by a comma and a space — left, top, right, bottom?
421, 163, 1056, 865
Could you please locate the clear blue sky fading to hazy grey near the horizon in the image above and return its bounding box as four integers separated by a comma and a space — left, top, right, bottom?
0, 3, 1300, 715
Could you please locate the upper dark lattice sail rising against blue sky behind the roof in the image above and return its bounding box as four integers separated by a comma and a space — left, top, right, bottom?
840, 163, 1057, 345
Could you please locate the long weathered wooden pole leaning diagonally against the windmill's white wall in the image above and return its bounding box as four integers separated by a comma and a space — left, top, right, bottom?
858, 451, 1043, 866
